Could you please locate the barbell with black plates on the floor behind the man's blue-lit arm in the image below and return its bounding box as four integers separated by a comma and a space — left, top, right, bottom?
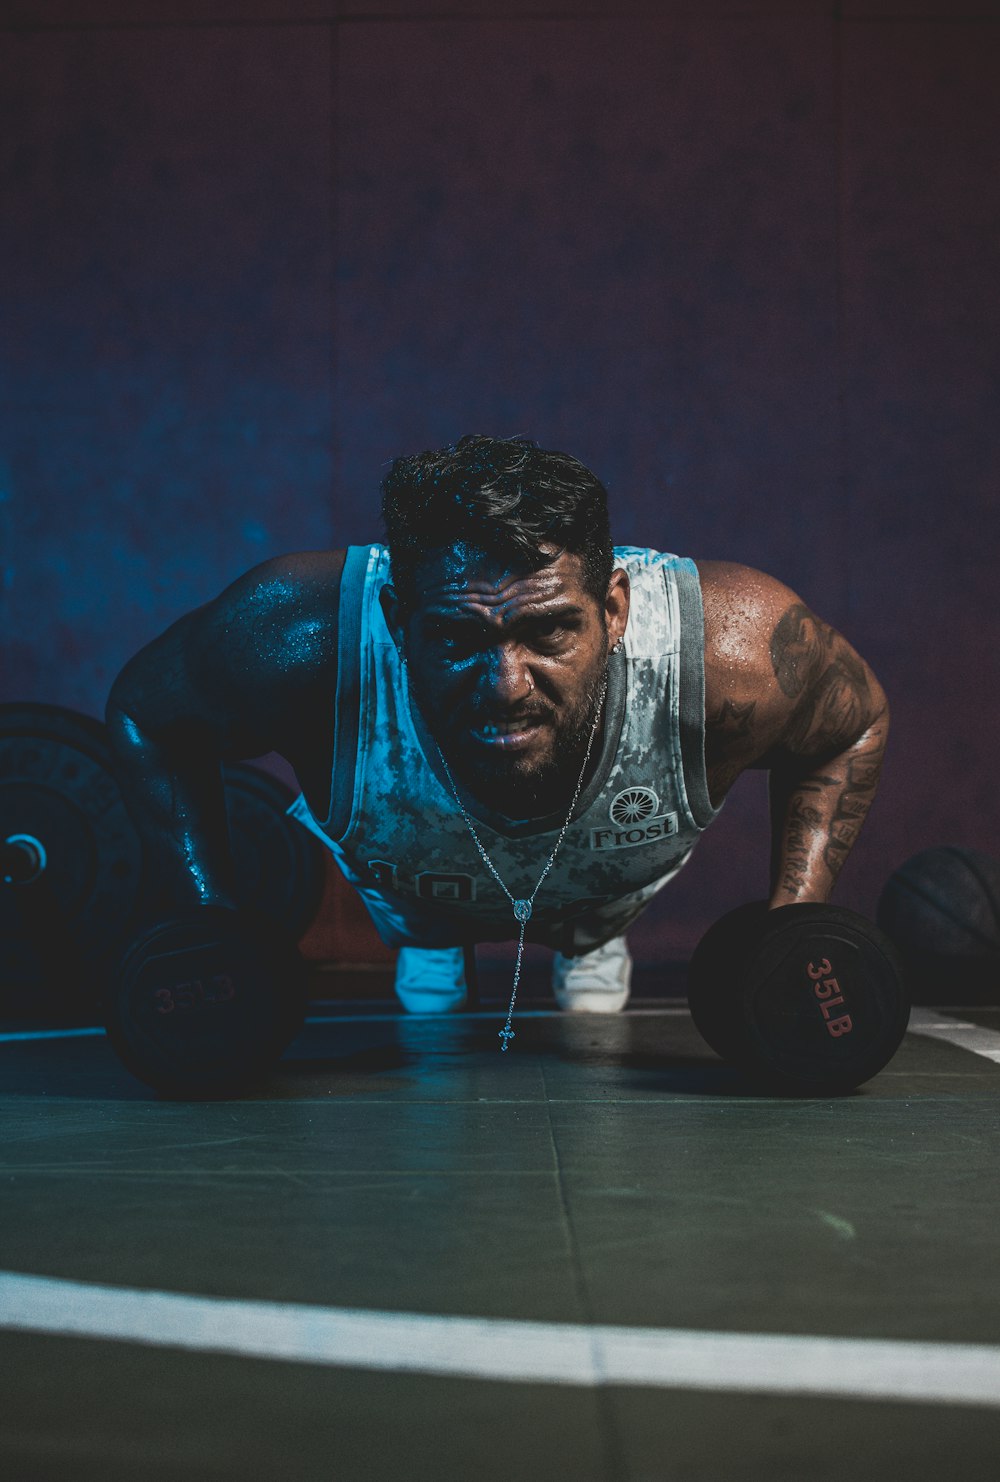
0, 701, 326, 1018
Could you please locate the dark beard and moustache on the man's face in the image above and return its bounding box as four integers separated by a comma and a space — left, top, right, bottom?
439, 655, 607, 818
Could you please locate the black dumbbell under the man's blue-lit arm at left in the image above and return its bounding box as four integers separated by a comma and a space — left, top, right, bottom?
105, 907, 305, 1097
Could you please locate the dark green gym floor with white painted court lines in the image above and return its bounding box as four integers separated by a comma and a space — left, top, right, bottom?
0, 977, 1000, 1482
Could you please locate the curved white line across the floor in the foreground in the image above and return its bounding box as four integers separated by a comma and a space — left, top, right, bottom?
0, 1272, 1000, 1409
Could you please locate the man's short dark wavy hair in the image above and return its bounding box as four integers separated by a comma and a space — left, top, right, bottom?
382, 434, 613, 617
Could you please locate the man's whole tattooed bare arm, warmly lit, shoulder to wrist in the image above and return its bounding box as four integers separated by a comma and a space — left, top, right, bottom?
698, 562, 889, 907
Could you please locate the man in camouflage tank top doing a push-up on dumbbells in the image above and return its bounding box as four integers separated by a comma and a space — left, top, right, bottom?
108, 436, 889, 1029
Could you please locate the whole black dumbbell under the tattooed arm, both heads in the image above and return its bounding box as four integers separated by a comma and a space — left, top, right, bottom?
687, 901, 910, 1095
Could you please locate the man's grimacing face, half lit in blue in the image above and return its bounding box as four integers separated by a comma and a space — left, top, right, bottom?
387, 544, 628, 817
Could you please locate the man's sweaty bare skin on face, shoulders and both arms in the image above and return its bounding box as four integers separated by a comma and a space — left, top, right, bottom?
107, 547, 889, 910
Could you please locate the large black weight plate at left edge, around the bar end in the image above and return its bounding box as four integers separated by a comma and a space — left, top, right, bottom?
0, 701, 141, 1014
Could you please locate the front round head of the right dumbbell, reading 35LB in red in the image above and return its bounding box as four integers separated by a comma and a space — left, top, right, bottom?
741, 904, 910, 1094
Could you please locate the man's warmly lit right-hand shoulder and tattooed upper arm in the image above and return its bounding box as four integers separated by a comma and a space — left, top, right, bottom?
696, 560, 886, 790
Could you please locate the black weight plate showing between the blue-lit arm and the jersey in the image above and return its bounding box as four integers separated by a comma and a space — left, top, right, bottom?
222, 762, 326, 938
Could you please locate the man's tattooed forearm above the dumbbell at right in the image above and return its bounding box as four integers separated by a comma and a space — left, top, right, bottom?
769, 707, 889, 907
